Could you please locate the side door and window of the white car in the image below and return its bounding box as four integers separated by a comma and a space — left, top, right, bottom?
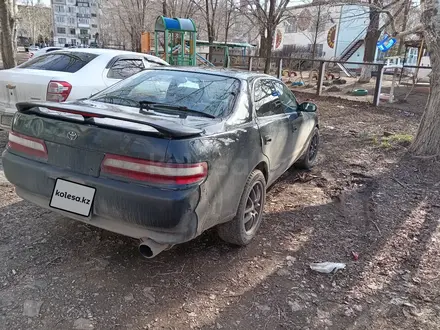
103, 57, 145, 87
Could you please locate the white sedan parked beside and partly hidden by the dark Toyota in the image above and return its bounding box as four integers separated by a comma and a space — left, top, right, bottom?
0, 48, 169, 128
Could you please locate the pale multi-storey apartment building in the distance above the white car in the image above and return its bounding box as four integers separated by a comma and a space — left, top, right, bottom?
51, 0, 100, 46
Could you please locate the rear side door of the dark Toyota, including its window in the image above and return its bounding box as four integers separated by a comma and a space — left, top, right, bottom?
253, 78, 292, 182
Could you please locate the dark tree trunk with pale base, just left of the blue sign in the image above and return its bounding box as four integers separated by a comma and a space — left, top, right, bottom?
359, 1, 380, 83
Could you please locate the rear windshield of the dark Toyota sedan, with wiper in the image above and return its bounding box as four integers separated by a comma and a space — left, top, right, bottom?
91, 70, 240, 117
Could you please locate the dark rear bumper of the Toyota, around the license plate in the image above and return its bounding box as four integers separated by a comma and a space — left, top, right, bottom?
3, 150, 200, 244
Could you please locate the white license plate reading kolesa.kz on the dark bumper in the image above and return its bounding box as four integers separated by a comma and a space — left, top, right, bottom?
49, 179, 96, 217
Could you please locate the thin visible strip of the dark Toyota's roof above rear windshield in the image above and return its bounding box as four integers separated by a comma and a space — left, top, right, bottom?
144, 66, 276, 80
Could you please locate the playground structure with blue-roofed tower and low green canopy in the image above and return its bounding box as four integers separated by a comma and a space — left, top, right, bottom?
141, 16, 254, 67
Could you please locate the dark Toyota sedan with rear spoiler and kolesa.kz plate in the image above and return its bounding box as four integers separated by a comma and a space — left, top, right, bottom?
3, 68, 319, 258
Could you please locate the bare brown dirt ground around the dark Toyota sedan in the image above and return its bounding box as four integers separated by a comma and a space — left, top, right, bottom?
0, 95, 440, 330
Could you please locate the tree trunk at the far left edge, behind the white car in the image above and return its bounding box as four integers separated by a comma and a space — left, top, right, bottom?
0, 0, 17, 69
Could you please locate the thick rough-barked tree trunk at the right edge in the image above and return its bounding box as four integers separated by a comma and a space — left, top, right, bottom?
410, 7, 440, 156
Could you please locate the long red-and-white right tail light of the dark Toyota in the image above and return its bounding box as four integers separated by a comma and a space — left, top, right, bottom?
101, 155, 208, 185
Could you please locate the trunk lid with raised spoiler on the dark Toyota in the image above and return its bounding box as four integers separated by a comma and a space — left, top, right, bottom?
8, 102, 202, 176
